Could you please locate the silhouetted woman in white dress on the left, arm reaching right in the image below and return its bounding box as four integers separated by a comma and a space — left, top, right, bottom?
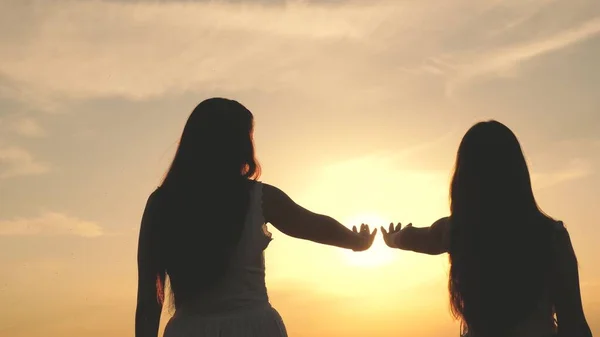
135, 98, 376, 337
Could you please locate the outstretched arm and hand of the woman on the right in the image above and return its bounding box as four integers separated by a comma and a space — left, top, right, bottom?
382, 217, 450, 255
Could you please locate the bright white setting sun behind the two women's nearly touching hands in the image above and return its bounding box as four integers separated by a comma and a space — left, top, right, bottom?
342, 214, 396, 267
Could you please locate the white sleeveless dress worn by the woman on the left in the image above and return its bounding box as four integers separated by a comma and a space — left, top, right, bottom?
164, 182, 287, 337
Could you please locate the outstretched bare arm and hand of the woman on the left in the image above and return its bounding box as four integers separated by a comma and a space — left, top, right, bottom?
263, 184, 376, 250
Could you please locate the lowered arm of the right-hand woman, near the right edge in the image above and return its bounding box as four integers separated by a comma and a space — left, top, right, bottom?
554, 229, 592, 337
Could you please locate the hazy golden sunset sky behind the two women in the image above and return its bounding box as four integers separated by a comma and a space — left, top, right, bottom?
0, 0, 600, 337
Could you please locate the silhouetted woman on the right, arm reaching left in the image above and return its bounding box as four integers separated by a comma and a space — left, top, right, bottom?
382, 121, 591, 337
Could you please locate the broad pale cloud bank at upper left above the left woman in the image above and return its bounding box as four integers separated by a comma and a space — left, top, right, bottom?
0, 1, 389, 101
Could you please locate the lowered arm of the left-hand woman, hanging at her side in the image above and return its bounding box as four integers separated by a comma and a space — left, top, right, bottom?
135, 194, 165, 337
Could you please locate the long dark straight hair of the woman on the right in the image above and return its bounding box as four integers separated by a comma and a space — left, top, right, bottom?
449, 120, 553, 336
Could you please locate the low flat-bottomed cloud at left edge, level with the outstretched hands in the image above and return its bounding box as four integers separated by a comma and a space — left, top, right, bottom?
0, 212, 103, 237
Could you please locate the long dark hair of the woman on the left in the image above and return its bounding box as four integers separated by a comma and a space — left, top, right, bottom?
156, 98, 260, 308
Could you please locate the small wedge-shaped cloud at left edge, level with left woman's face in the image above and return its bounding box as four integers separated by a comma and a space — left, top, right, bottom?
0, 145, 50, 180
